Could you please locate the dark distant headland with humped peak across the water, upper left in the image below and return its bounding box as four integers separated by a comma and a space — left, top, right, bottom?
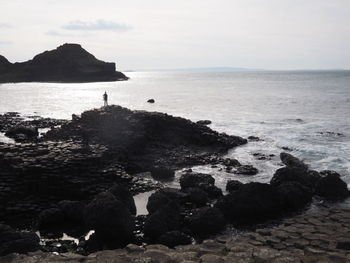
0, 44, 128, 83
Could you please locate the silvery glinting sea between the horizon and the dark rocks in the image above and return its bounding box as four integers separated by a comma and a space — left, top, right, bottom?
0, 71, 350, 194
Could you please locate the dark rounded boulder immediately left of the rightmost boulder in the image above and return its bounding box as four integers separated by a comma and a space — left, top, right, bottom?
277, 182, 312, 211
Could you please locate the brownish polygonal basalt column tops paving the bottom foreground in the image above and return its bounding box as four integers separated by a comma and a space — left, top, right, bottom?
4, 208, 350, 263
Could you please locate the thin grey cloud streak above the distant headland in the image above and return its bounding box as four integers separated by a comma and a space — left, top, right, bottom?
62, 19, 131, 32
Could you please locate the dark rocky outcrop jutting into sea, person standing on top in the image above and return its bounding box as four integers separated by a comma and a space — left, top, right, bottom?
44, 106, 247, 173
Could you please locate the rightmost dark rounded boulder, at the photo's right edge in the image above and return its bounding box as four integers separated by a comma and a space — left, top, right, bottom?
315, 171, 350, 201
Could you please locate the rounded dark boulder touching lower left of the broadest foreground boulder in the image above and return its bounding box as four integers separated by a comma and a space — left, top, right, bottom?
188, 207, 226, 237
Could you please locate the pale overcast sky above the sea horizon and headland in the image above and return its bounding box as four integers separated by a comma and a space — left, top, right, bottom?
0, 0, 350, 70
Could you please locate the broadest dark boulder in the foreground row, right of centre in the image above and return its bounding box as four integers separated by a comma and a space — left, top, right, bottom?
215, 183, 282, 225
